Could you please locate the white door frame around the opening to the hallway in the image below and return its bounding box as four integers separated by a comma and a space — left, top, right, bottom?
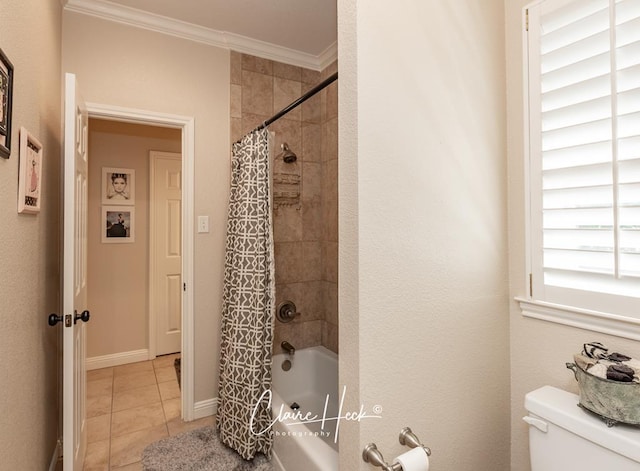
86, 102, 195, 421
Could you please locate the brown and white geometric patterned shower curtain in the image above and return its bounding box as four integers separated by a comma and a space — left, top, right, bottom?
217, 129, 275, 460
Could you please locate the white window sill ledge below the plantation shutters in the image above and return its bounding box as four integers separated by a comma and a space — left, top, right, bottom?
515, 297, 640, 340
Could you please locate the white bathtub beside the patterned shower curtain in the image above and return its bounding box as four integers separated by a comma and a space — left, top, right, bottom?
271, 347, 339, 471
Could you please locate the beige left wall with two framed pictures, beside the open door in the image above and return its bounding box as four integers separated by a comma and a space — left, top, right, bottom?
0, 0, 62, 470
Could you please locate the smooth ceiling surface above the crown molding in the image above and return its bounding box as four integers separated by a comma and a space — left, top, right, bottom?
65, 0, 337, 70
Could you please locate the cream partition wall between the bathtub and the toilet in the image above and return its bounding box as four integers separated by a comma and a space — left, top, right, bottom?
338, 0, 509, 471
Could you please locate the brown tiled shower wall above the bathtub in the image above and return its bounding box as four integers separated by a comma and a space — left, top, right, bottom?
231, 51, 338, 353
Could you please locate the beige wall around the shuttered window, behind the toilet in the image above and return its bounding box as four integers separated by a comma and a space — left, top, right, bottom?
505, 0, 640, 471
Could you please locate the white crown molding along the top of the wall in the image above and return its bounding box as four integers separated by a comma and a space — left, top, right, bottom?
63, 0, 338, 71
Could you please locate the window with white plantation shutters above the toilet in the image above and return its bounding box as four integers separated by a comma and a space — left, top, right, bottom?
525, 0, 640, 339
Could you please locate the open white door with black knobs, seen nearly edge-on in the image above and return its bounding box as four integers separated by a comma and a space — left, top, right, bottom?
62, 74, 89, 471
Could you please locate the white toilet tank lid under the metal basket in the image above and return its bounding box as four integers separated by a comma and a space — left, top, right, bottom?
524, 386, 640, 463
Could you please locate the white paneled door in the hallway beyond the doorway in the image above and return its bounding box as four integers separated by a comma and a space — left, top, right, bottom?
150, 151, 182, 355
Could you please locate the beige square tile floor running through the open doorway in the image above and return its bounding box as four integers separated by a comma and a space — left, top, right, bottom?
84, 354, 214, 471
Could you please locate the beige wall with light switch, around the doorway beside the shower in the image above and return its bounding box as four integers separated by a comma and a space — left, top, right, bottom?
62, 12, 230, 402
